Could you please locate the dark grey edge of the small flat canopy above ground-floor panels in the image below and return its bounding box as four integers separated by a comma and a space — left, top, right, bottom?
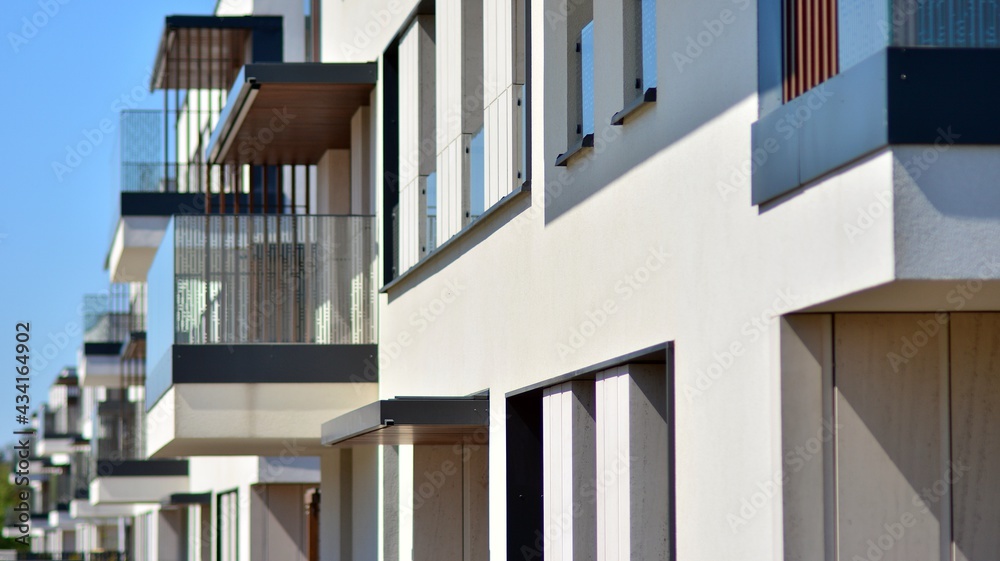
320, 397, 490, 446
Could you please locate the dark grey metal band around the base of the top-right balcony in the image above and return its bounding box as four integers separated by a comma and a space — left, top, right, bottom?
751, 47, 1000, 204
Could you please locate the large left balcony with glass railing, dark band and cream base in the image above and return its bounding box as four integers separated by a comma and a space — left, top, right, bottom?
146, 215, 377, 457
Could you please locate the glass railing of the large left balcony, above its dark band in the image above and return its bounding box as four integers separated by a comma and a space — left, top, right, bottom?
149, 215, 377, 346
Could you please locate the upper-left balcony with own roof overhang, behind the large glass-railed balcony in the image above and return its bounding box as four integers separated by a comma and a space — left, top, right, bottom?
113, 16, 283, 282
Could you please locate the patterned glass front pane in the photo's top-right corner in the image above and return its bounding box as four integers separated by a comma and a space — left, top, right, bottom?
893, 0, 1000, 47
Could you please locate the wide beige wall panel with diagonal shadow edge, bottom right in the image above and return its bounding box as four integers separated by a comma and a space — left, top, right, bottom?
834, 314, 950, 561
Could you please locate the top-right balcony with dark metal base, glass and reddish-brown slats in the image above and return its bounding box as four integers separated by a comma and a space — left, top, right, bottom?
748, 0, 1000, 204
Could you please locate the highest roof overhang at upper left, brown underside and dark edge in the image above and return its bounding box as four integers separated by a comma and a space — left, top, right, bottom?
150, 15, 284, 90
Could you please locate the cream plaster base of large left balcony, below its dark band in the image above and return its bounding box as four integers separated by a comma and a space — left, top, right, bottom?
146, 382, 378, 458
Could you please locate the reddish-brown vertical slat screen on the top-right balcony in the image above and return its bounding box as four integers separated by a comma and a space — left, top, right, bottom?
782, 0, 838, 102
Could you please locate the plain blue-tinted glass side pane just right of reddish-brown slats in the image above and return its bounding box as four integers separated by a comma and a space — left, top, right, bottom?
837, 0, 892, 72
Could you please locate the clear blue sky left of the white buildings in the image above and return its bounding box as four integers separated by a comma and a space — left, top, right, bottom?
0, 0, 215, 443
